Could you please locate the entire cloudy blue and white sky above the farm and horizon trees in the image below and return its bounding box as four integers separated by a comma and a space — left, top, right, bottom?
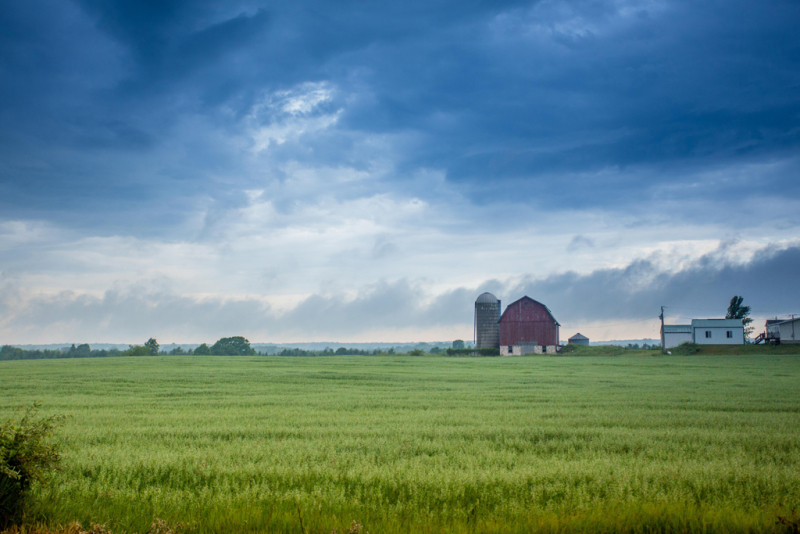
0, 0, 800, 344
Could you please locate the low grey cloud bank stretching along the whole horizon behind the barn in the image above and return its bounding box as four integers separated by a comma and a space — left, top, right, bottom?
0, 247, 800, 343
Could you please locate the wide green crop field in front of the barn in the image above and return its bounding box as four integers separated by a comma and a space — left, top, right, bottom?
0, 352, 800, 534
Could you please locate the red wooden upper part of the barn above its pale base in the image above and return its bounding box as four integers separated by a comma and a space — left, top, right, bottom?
500, 297, 561, 346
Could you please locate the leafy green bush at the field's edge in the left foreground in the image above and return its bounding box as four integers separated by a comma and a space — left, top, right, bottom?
0, 403, 64, 529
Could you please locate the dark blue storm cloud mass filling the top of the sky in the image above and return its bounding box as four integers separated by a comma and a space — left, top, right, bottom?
0, 0, 800, 233
